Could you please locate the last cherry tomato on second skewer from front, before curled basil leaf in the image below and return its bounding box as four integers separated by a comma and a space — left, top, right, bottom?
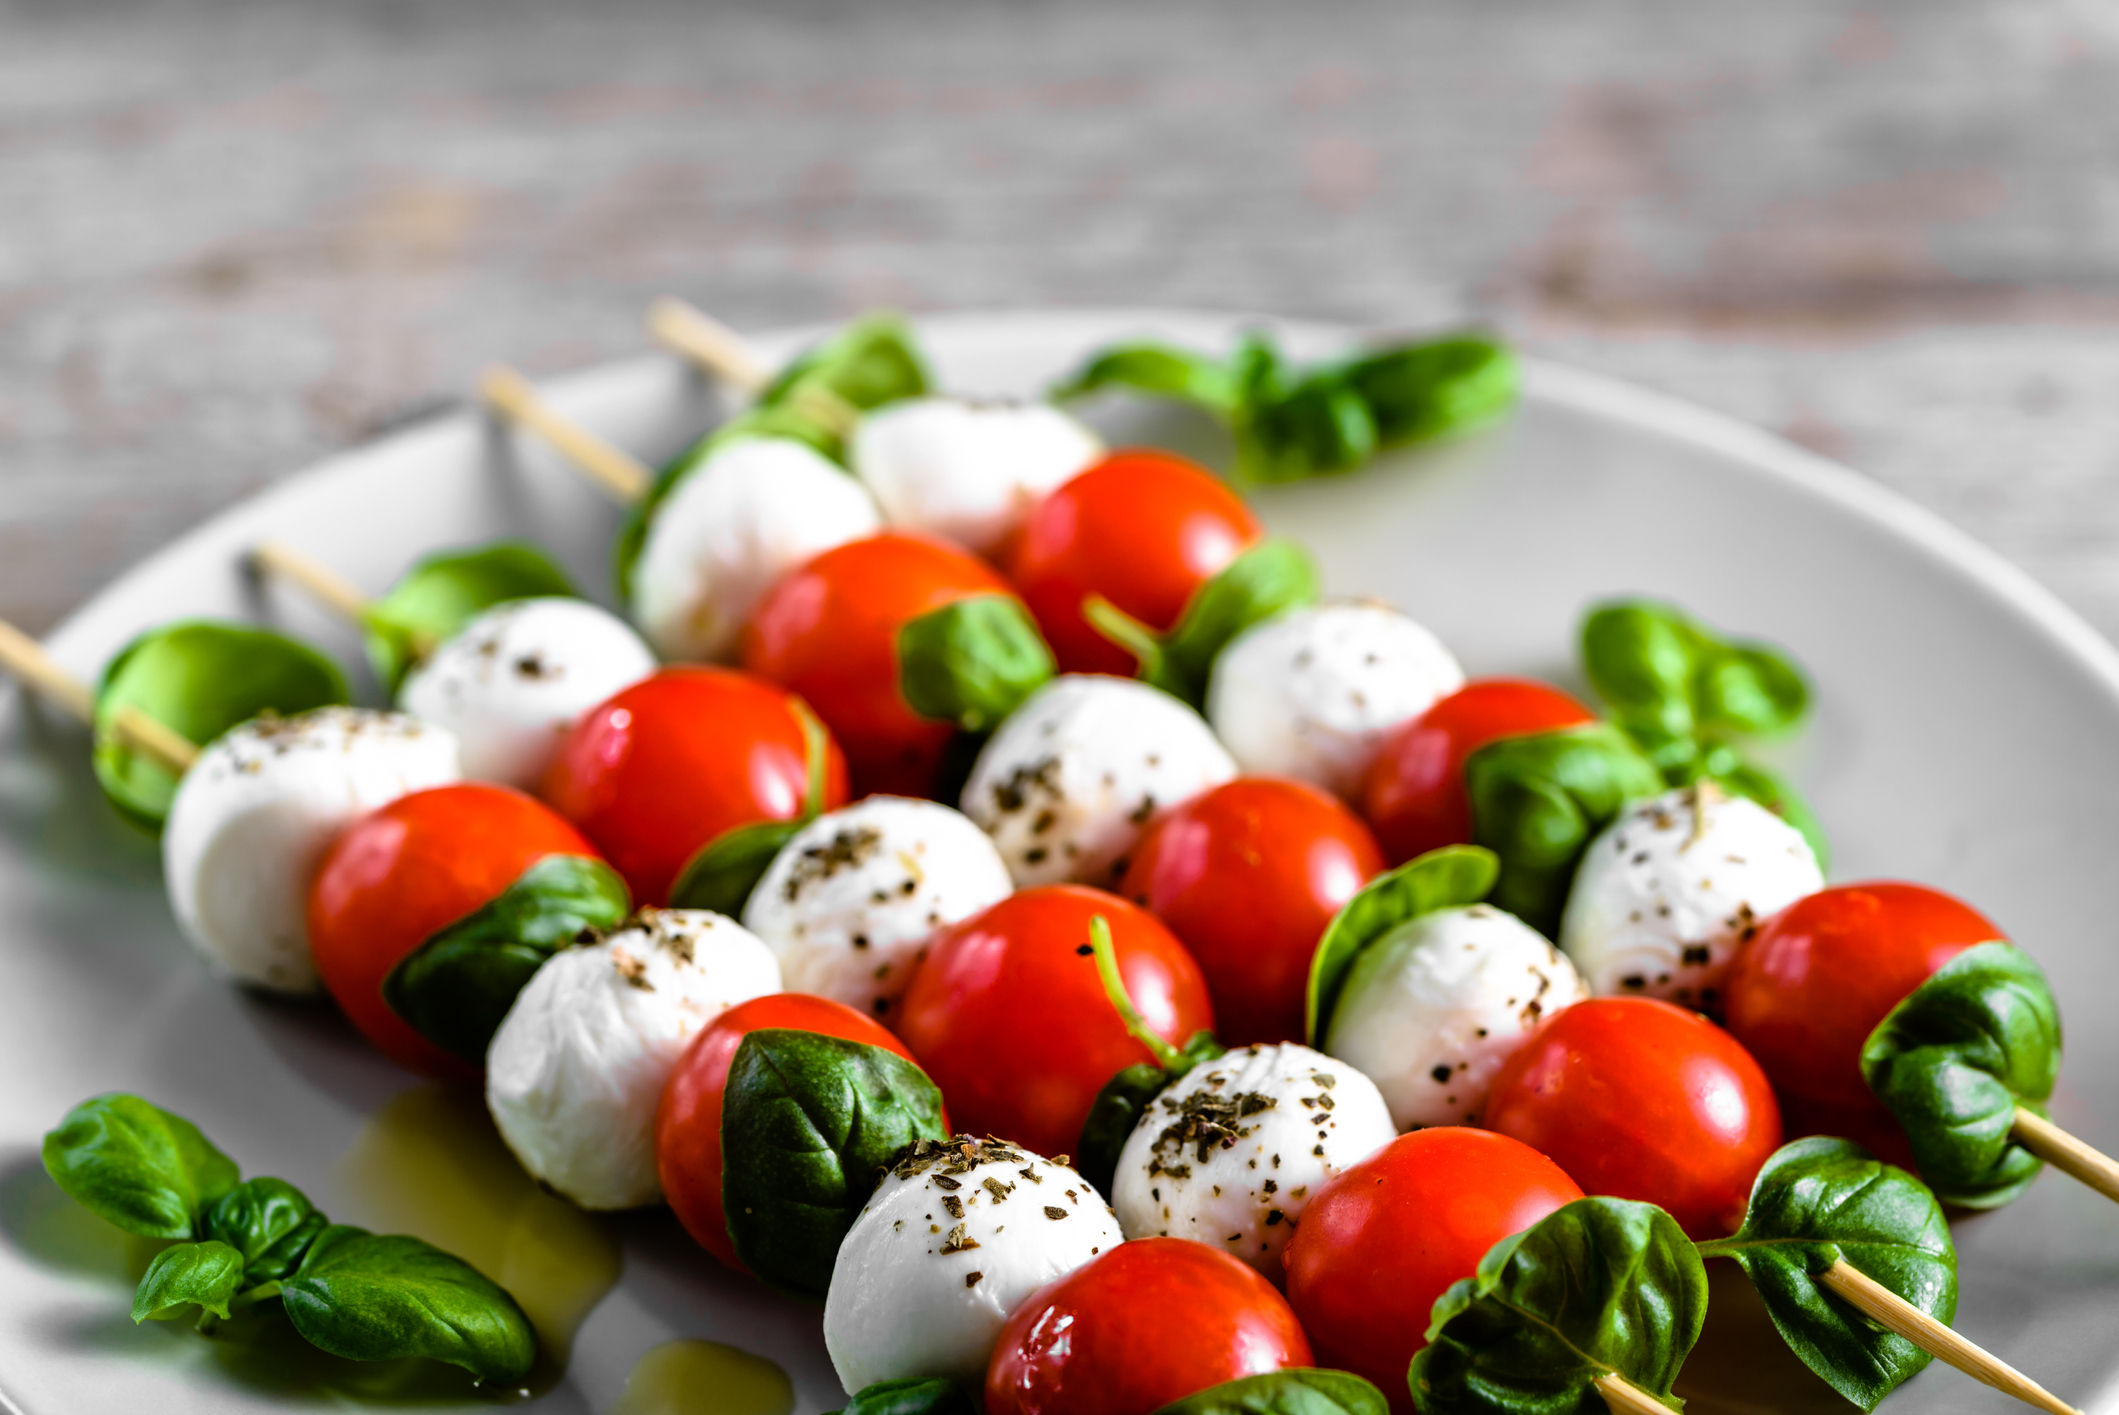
1286, 1125, 1583, 1411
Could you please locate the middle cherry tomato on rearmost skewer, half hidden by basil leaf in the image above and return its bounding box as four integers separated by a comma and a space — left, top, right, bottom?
1363, 678, 1596, 864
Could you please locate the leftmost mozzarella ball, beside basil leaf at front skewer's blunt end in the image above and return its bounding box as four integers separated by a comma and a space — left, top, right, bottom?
161, 708, 460, 993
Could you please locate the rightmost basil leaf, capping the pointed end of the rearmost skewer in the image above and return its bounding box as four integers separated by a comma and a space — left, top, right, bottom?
1860, 943, 2060, 1210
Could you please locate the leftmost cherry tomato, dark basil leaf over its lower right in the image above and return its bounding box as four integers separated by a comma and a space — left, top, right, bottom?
309, 782, 595, 1076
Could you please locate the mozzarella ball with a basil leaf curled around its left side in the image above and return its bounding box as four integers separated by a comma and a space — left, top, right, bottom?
1324, 904, 1589, 1129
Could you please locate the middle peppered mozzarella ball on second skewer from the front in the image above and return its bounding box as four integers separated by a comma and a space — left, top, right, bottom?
744, 796, 1015, 1017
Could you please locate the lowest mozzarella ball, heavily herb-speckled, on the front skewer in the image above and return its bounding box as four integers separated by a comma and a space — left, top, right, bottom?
824, 1135, 1123, 1390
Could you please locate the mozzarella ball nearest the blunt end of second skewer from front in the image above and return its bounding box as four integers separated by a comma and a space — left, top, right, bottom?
398, 597, 655, 790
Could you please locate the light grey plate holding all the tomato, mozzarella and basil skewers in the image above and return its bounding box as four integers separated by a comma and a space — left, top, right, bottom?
0, 303, 2119, 1415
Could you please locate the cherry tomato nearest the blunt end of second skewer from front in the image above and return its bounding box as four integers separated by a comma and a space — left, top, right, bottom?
542, 667, 845, 904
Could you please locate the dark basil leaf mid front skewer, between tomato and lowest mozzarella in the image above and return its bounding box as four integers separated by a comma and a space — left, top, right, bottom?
720, 1029, 949, 1301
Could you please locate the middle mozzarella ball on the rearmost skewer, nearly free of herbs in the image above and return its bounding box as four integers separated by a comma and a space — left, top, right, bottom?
1206, 604, 1464, 799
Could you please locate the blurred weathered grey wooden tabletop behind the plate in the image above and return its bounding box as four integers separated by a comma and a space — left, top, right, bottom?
0, 0, 2119, 635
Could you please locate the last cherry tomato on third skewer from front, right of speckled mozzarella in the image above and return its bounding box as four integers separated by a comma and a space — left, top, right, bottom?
1485, 998, 1780, 1241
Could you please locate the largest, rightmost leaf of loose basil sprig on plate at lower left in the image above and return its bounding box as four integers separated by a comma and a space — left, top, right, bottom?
280, 1224, 536, 1383
